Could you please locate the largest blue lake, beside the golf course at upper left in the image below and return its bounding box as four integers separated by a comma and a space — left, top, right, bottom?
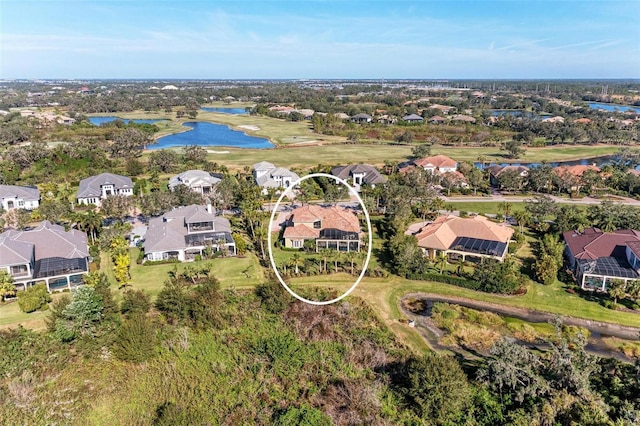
149, 121, 275, 149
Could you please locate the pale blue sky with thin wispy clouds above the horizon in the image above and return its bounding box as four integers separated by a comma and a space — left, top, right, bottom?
0, 0, 640, 79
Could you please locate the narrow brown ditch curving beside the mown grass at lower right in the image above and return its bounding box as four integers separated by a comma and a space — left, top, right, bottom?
398, 293, 640, 340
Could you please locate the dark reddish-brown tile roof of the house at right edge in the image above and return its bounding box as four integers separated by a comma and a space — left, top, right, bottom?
562, 228, 640, 260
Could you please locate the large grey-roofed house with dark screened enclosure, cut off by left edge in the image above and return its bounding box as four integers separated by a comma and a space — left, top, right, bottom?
0, 221, 89, 291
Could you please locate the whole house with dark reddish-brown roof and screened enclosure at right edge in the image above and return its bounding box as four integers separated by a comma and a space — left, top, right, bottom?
562, 228, 640, 291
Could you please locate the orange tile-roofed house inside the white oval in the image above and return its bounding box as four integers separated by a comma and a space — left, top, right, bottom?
283, 204, 362, 251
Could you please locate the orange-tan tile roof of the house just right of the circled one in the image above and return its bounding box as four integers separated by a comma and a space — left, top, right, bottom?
415, 215, 513, 250
